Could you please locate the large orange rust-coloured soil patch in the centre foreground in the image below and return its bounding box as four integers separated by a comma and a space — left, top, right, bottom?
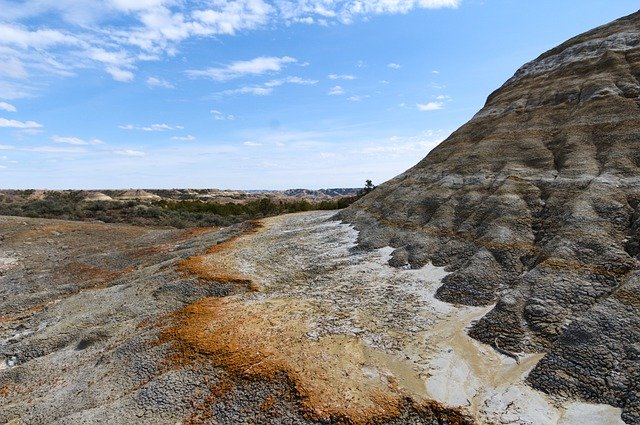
161, 298, 402, 424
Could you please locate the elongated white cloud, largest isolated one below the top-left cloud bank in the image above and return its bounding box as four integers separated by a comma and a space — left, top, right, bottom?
187, 56, 296, 81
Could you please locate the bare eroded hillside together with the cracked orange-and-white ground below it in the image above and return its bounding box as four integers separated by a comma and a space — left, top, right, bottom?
0, 8, 640, 425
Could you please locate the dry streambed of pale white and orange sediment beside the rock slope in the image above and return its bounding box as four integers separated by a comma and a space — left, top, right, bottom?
170, 212, 623, 425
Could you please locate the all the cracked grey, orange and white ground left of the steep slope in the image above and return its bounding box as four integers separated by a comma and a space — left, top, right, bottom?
0, 212, 622, 425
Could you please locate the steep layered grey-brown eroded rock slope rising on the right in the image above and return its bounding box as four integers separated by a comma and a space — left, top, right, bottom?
342, 12, 640, 423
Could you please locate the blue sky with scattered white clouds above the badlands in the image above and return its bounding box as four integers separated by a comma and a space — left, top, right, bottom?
0, 0, 638, 189
